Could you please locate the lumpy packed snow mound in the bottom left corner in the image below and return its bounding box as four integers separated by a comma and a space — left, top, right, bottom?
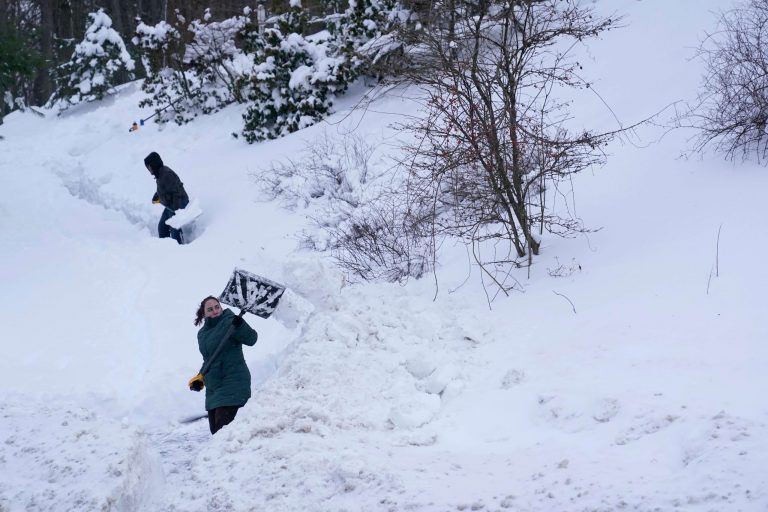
0, 399, 165, 512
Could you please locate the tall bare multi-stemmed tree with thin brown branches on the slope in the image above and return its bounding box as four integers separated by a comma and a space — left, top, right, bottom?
376, 0, 620, 290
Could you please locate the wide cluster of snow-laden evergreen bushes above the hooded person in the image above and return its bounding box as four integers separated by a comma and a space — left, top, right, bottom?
127, 0, 396, 139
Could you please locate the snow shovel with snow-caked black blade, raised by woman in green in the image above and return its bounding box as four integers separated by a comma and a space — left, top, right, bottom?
180, 268, 285, 423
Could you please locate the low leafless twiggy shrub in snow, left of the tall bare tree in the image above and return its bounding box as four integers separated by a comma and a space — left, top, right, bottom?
254, 128, 433, 281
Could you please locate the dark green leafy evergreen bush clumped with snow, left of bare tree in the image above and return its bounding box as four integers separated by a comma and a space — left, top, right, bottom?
242, 0, 353, 142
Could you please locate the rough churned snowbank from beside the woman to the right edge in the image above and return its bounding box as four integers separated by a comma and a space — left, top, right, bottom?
140, 276, 768, 512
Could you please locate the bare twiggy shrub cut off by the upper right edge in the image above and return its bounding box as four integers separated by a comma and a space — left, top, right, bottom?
677, 0, 768, 161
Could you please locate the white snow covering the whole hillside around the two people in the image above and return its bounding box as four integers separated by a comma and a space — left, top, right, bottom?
0, 0, 768, 512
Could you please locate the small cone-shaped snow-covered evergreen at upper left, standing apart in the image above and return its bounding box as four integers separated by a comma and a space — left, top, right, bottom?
53, 9, 135, 105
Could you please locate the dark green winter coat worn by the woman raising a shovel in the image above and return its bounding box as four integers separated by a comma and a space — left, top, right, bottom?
197, 309, 258, 411
